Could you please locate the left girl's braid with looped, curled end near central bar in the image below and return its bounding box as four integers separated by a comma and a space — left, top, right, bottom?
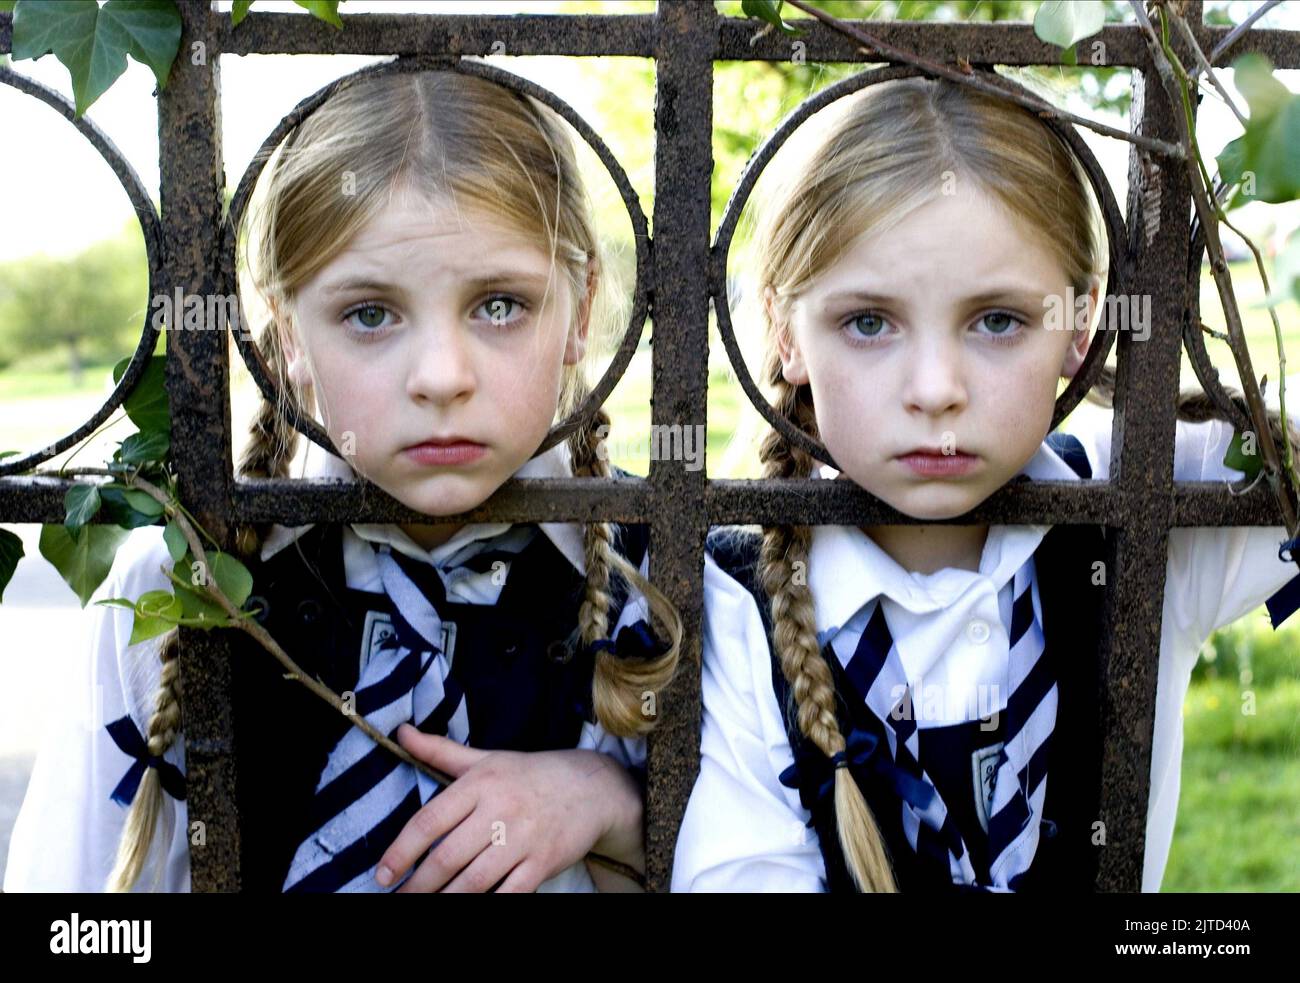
569, 400, 681, 737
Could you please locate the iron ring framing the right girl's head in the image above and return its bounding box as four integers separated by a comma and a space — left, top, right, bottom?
709, 65, 1130, 469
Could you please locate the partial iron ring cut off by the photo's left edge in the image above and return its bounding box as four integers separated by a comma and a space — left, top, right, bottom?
0, 68, 163, 477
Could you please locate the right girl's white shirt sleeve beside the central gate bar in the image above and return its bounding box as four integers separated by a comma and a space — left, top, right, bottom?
672, 557, 826, 892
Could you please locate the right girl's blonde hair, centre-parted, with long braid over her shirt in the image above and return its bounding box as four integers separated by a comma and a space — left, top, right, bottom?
754, 78, 1296, 891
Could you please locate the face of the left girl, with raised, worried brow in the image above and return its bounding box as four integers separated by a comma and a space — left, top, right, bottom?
285, 187, 594, 515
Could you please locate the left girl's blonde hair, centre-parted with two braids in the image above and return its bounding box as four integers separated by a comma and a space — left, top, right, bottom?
109, 70, 681, 891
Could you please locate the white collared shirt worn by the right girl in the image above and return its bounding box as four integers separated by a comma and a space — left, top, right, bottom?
672, 407, 1297, 891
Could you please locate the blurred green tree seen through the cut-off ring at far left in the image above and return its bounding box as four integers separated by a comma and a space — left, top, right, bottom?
0, 220, 148, 385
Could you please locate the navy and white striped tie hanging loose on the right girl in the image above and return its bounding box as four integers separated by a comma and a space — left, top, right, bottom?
831, 557, 1057, 891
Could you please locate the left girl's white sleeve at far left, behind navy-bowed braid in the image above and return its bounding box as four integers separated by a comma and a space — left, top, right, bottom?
4, 527, 190, 893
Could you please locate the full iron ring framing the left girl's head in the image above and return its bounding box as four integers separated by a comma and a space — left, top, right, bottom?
220, 55, 650, 458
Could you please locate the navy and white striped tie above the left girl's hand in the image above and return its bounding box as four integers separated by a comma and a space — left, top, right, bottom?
283, 546, 469, 892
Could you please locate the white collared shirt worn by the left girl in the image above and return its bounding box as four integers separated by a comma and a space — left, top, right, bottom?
4, 442, 647, 893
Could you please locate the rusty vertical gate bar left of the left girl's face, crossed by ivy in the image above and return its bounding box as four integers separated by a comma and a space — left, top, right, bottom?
159, 3, 239, 891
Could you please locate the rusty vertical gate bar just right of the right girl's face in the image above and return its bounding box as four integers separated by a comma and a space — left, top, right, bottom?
1097, 4, 1200, 891
